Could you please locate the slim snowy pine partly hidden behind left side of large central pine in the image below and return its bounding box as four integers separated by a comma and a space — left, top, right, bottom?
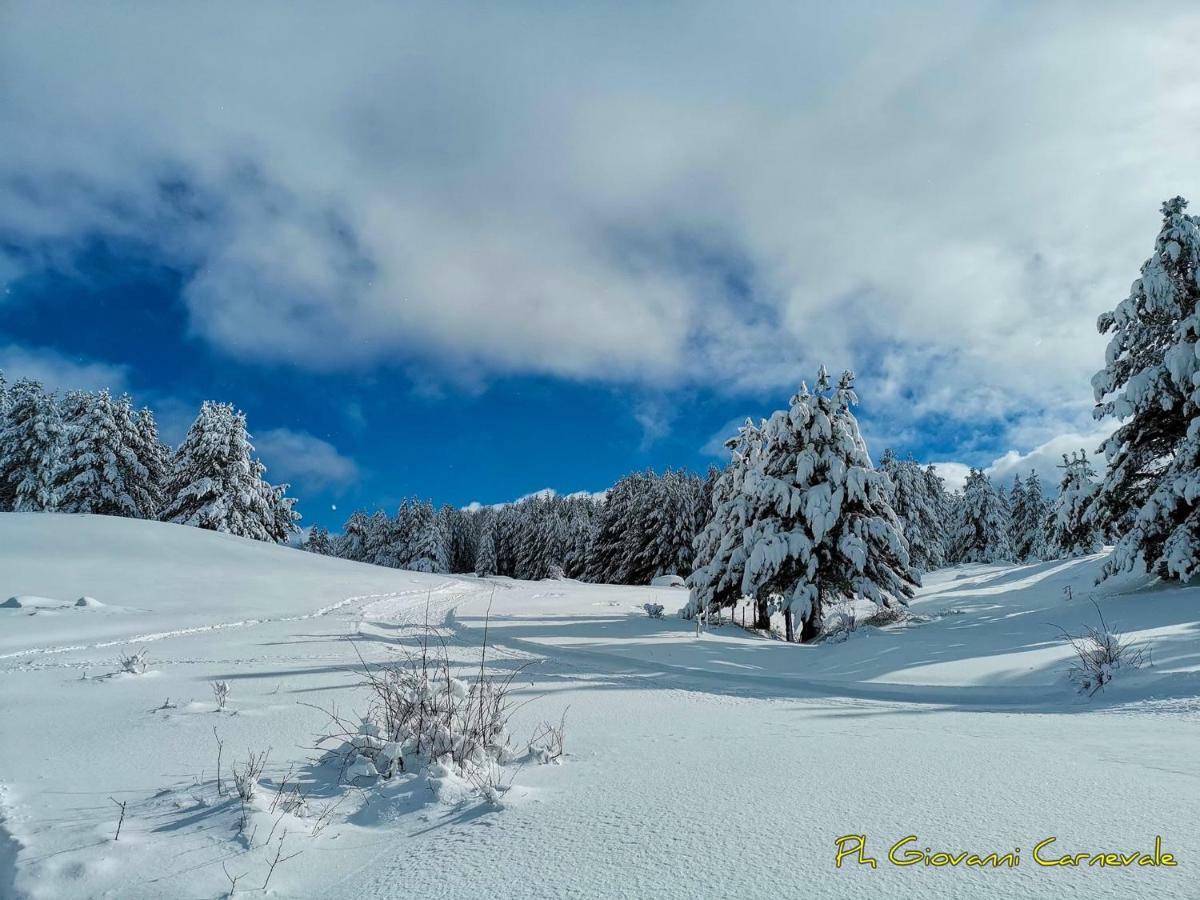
684, 419, 770, 629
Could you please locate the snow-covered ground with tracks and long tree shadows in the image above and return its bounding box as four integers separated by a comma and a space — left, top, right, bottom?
0, 514, 1200, 898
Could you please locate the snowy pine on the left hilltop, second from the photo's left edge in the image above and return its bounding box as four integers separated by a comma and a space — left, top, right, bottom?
58, 390, 140, 517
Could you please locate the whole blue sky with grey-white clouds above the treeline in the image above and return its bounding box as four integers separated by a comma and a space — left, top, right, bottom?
0, 2, 1200, 524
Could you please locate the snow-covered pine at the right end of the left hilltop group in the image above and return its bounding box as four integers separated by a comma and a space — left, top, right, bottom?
162, 401, 278, 541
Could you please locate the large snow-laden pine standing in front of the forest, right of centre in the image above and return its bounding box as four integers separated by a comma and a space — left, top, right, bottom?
742, 366, 919, 642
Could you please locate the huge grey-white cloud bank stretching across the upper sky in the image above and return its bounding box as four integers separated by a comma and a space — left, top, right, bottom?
0, 2, 1200, 445
